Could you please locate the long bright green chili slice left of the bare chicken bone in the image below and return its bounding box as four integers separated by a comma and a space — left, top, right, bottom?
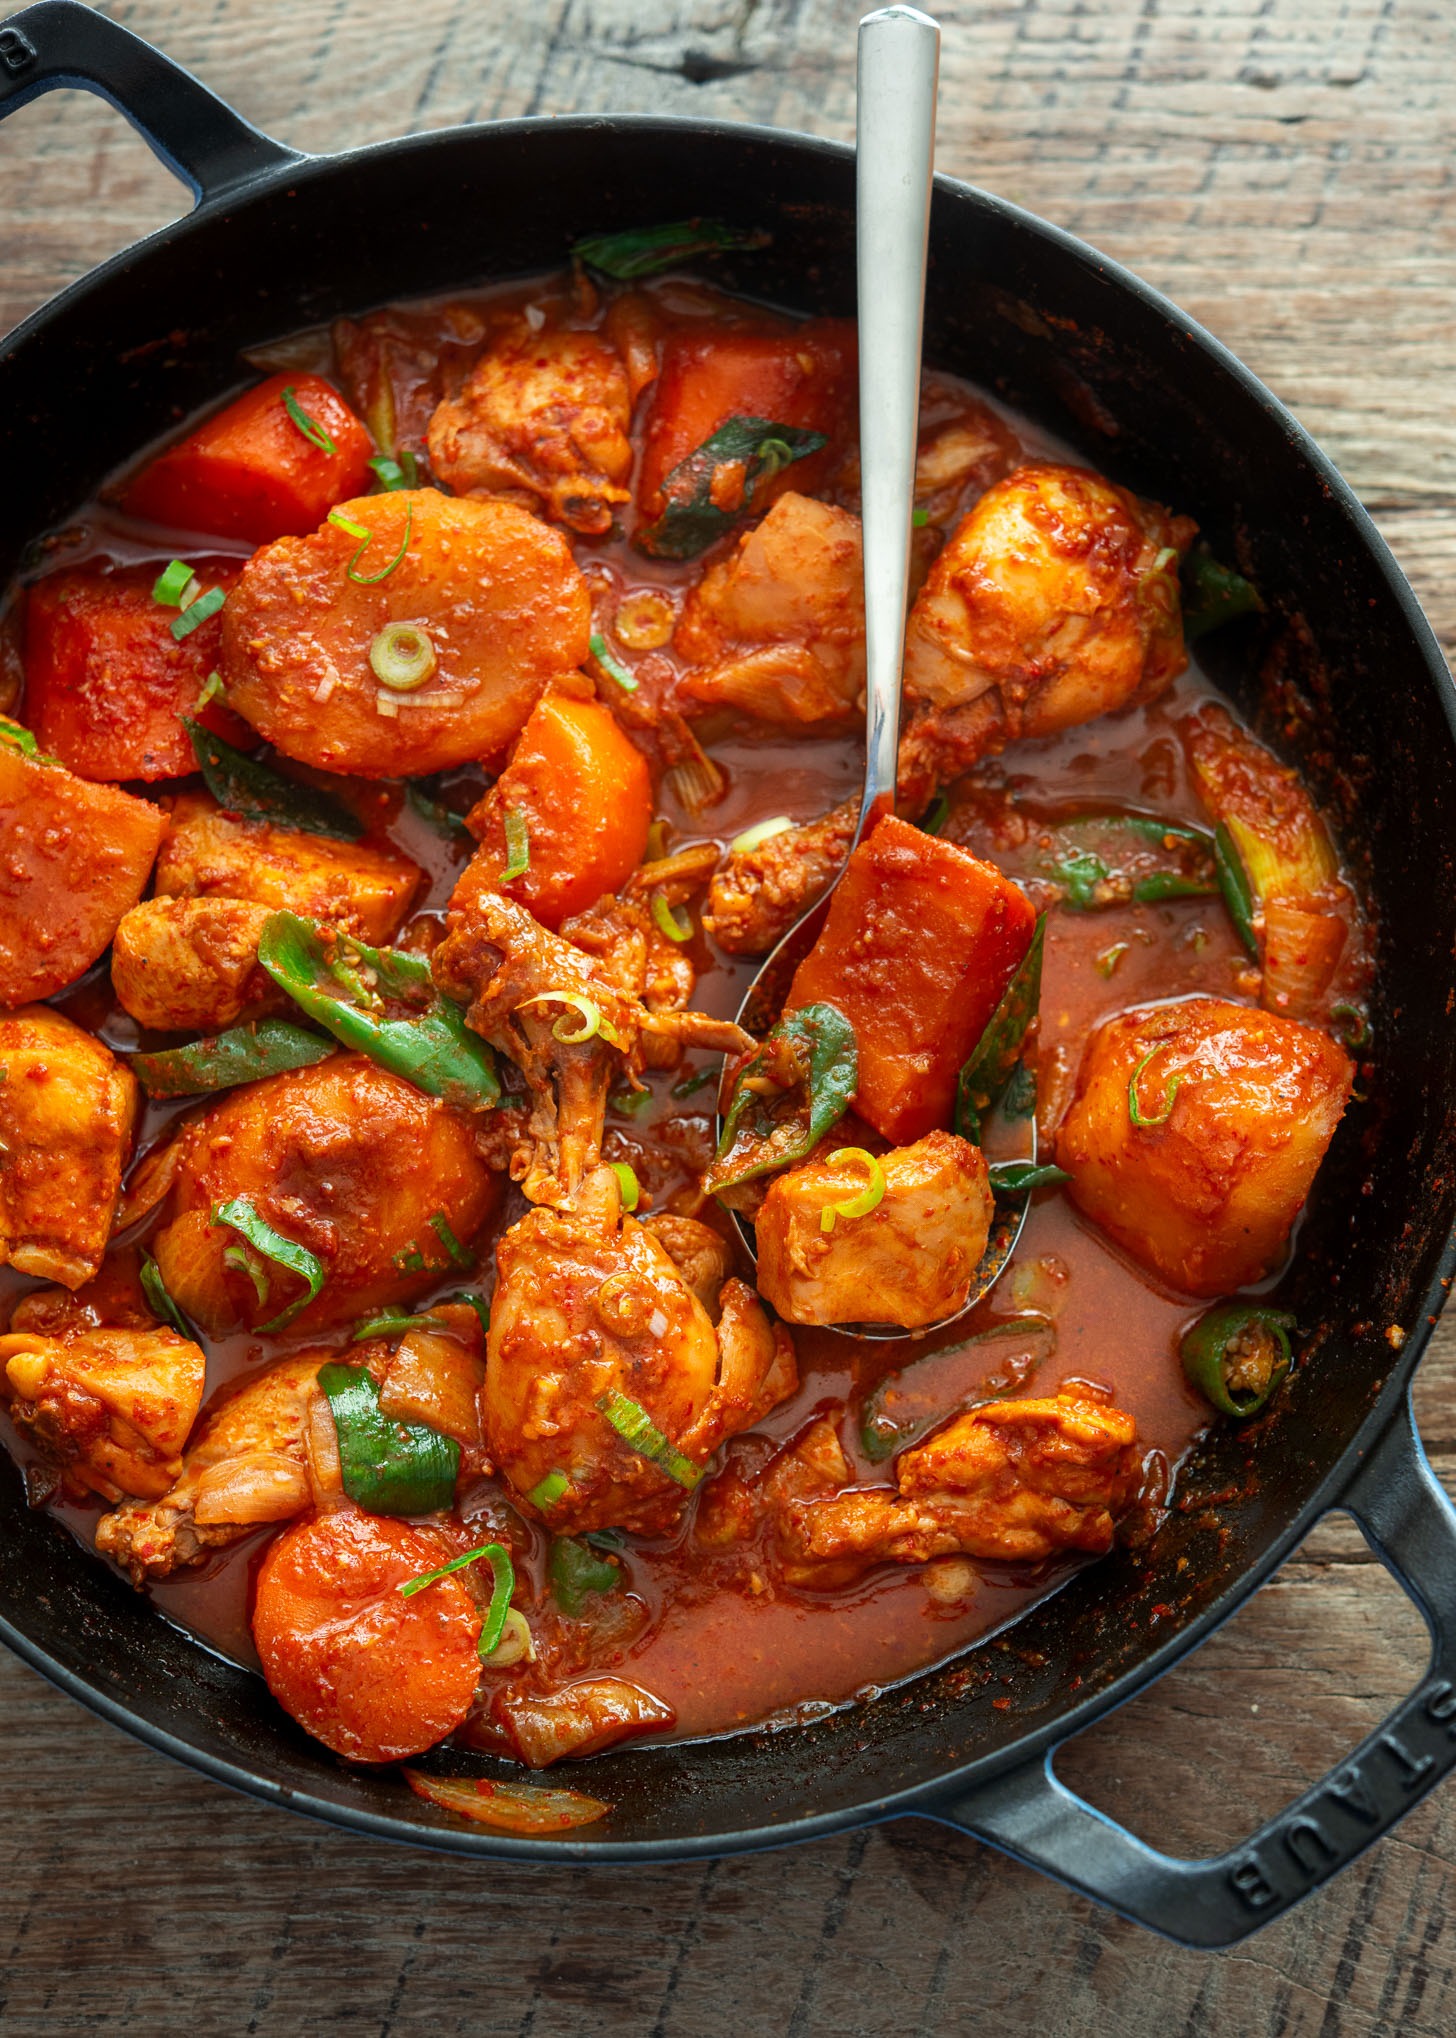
257, 913, 500, 1111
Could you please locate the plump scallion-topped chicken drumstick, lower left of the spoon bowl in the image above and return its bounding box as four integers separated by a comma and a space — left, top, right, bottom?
483, 1168, 797, 1535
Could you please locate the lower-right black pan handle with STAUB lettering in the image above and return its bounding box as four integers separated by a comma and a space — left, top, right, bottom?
926, 1402, 1456, 1948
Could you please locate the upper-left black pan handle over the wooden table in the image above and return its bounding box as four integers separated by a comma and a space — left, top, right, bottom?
0, 0, 304, 204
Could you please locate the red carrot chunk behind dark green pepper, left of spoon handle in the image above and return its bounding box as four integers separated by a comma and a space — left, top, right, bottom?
636, 318, 859, 518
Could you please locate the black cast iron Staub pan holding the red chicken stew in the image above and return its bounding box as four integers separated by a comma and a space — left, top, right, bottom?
0, 0, 1456, 1946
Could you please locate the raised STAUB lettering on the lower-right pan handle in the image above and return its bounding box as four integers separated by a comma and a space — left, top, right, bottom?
1228, 1679, 1456, 1912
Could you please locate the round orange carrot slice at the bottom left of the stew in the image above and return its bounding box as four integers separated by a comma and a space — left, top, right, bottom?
253, 1508, 481, 1763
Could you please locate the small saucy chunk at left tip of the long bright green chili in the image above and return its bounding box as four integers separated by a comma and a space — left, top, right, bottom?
112, 899, 277, 1033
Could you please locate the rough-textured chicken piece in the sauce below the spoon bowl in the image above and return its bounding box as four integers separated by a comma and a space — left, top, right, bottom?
779, 1388, 1140, 1586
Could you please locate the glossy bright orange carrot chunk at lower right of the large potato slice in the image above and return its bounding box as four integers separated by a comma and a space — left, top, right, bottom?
451, 693, 653, 929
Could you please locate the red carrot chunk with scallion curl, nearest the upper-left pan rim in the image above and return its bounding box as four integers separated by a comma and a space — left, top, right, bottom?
122, 375, 373, 544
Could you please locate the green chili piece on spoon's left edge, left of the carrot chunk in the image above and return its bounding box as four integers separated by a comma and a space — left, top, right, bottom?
704, 1005, 859, 1194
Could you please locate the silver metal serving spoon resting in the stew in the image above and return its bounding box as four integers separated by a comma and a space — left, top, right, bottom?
718, 6, 1036, 1339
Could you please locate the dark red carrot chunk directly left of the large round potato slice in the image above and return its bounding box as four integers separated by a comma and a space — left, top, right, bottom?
24, 558, 251, 783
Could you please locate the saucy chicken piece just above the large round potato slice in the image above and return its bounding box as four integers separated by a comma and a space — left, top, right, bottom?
428, 314, 632, 536
